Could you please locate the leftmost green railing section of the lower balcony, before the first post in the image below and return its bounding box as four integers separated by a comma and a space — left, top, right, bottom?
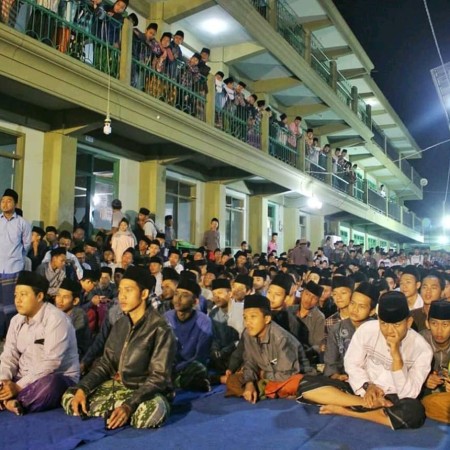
1, 0, 122, 78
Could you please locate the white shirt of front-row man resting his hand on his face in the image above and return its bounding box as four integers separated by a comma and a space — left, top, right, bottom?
344, 320, 433, 399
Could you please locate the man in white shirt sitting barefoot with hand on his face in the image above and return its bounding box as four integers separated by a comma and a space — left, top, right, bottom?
299, 292, 433, 430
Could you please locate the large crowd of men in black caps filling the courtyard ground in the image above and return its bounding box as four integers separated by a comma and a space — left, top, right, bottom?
0, 189, 450, 430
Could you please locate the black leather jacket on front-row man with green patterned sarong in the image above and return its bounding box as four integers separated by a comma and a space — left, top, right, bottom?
76, 307, 176, 412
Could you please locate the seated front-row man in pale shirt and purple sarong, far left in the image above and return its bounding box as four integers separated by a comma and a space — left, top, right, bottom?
0, 272, 80, 415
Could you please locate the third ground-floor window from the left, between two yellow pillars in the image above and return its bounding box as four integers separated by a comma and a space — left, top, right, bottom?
165, 178, 195, 242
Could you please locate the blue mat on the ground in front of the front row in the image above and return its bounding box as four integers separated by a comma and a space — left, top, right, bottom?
0, 387, 450, 450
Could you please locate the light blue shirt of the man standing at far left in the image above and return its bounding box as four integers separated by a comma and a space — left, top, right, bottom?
0, 213, 31, 273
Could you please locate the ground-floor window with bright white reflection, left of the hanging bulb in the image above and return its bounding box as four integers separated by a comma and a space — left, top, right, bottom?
75, 150, 119, 234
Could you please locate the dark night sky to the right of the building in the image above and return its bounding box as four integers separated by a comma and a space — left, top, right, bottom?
334, 0, 450, 225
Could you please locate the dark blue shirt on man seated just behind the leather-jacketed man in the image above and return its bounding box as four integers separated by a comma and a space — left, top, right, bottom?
164, 309, 212, 372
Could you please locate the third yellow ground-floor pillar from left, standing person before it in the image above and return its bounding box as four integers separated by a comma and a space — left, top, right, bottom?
200, 181, 227, 248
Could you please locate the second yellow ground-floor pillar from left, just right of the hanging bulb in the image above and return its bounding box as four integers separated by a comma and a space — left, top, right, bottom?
139, 161, 166, 226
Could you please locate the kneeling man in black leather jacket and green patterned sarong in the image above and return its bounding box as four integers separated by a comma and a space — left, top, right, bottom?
62, 267, 175, 429
